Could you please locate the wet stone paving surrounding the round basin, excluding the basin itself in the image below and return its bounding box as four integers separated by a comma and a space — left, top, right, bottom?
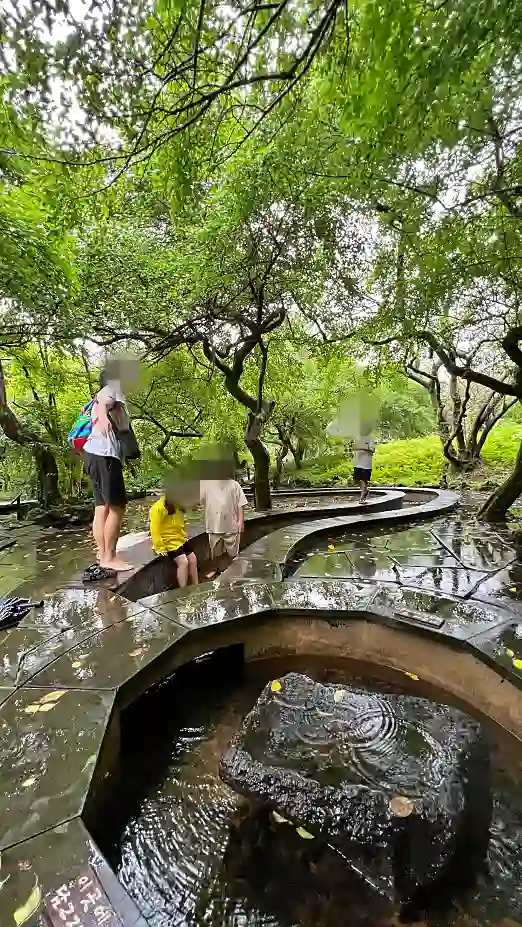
0, 490, 522, 927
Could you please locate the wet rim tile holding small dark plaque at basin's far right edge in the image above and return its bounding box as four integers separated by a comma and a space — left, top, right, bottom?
372, 585, 507, 640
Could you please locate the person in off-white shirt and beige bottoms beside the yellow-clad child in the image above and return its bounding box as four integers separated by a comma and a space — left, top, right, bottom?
200, 468, 248, 560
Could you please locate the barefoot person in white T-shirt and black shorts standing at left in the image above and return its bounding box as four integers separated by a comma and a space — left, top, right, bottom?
83, 361, 132, 581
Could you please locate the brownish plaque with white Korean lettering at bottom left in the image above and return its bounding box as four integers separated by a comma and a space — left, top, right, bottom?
43, 866, 123, 927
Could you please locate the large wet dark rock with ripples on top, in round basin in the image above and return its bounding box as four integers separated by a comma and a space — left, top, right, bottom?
220, 673, 492, 910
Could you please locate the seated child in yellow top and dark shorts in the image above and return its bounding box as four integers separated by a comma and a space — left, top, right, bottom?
149, 488, 198, 587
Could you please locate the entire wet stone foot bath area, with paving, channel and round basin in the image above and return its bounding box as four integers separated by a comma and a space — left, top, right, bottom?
0, 488, 522, 927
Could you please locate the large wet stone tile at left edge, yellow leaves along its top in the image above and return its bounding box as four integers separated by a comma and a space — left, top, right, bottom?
0, 688, 114, 852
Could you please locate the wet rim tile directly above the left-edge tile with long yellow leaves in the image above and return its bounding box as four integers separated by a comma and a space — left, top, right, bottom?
29, 609, 186, 689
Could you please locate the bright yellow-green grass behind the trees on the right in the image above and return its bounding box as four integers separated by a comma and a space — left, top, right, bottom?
283, 422, 522, 488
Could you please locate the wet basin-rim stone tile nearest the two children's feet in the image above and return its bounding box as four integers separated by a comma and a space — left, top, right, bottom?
143, 582, 273, 628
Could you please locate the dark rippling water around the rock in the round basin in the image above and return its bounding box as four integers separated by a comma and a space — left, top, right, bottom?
102, 654, 522, 927
